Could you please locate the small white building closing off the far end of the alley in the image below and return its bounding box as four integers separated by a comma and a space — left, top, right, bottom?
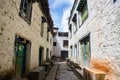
53, 28, 68, 60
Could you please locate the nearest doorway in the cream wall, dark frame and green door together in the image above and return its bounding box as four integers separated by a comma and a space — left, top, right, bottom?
15, 35, 30, 77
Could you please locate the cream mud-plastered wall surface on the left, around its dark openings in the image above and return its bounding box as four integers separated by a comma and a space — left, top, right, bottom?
0, 0, 52, 72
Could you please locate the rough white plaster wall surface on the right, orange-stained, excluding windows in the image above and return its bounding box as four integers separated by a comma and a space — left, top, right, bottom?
69, 0, 120, 80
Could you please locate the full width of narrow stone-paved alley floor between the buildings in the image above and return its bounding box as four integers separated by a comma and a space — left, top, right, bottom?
46, 62, 80, 80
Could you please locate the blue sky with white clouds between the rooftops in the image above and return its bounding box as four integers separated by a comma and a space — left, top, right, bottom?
48, 0, 74, 32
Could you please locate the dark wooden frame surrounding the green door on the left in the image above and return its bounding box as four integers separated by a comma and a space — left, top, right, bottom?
14, 35, 31, 77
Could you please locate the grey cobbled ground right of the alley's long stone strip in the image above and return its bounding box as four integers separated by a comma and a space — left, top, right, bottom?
56, 62, 79, 80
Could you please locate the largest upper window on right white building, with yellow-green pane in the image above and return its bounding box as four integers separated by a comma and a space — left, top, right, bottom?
77, 0, 88, 23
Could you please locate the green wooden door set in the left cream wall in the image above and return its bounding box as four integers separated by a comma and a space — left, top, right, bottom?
15, 43, 26, 77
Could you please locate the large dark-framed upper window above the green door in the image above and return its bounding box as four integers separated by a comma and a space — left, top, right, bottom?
19, 0, 32, 24
